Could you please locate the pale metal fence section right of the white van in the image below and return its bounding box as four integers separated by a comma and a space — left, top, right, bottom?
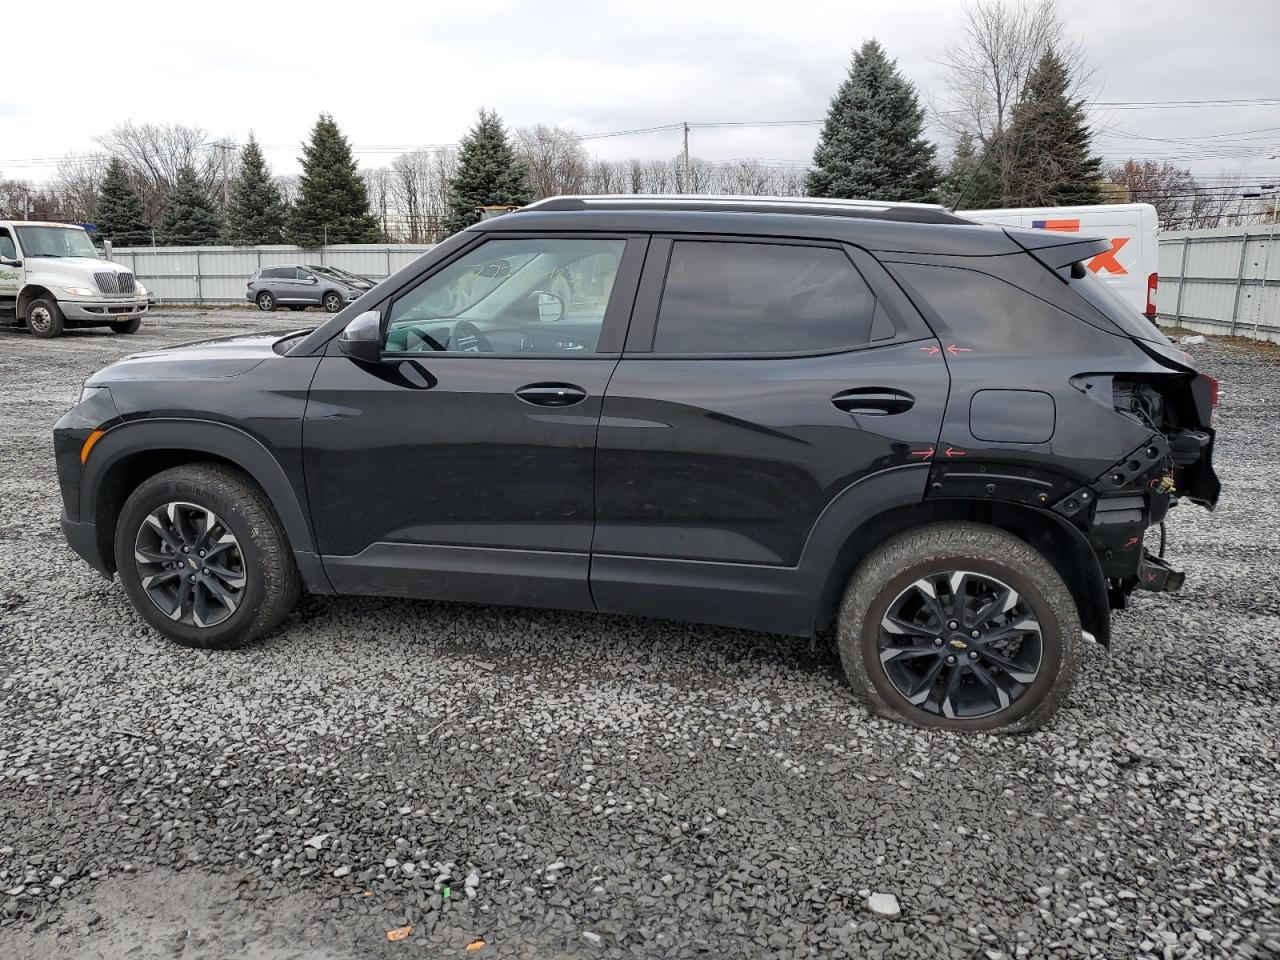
1156, 224, 1280, 343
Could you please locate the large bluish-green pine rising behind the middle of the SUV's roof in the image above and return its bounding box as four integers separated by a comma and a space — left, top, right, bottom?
805, 40, 940, 202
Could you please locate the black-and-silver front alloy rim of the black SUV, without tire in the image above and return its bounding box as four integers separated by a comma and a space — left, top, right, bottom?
133, 502, 247, 627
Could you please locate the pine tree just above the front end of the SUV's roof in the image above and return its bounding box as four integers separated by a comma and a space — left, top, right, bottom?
444, 110, 534, 233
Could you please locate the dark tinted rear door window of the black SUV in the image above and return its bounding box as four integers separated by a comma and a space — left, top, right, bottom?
653, 241, 876, 353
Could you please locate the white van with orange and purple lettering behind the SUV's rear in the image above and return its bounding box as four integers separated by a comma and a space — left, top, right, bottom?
956, 204, 1160, 323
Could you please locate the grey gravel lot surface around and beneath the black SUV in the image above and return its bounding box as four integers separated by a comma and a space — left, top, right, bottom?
0, 311, 1280, 960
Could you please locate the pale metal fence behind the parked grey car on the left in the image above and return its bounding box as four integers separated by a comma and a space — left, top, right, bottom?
111, 243, 431, 303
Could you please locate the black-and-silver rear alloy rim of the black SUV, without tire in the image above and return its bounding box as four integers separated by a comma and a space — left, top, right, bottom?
877, 570, 1044, 719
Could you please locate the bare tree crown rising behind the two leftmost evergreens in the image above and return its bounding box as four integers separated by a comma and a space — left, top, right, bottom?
95, 120, 217, 220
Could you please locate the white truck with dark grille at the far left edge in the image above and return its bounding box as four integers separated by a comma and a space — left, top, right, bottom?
0, 220, 147, 337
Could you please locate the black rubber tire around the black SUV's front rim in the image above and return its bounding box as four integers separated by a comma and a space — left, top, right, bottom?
115, 463, 301, 649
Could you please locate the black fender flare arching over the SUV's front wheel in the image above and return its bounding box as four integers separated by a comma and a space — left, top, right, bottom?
79, 419, 332, 593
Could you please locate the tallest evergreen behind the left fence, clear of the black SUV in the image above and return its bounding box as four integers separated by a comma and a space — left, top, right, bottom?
285, 114, 378, 247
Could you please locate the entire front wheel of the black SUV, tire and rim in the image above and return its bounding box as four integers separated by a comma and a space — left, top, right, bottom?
115, 463, 301, 649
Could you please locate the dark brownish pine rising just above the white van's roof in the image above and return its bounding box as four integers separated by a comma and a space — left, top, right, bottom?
1004, 47, 1102, 206
